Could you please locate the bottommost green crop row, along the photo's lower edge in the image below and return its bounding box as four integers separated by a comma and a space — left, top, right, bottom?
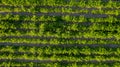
0, 60, 120, 67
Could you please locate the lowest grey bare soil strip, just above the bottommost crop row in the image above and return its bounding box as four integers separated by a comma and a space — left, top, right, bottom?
0, 59, 120, 63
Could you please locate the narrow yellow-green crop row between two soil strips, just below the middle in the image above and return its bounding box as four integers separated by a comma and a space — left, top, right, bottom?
0, 38, 120, 45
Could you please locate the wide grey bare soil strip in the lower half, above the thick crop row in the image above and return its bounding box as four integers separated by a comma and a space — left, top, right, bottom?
0, 42, 120, 48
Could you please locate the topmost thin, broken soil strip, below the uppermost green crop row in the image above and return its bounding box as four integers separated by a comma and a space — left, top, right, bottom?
0, 4, 120, 10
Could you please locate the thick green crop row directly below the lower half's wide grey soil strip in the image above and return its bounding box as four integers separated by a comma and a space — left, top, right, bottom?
0, 45, 120, 57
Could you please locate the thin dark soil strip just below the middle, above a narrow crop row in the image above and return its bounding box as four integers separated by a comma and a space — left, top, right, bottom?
0, 35, 116, 40
